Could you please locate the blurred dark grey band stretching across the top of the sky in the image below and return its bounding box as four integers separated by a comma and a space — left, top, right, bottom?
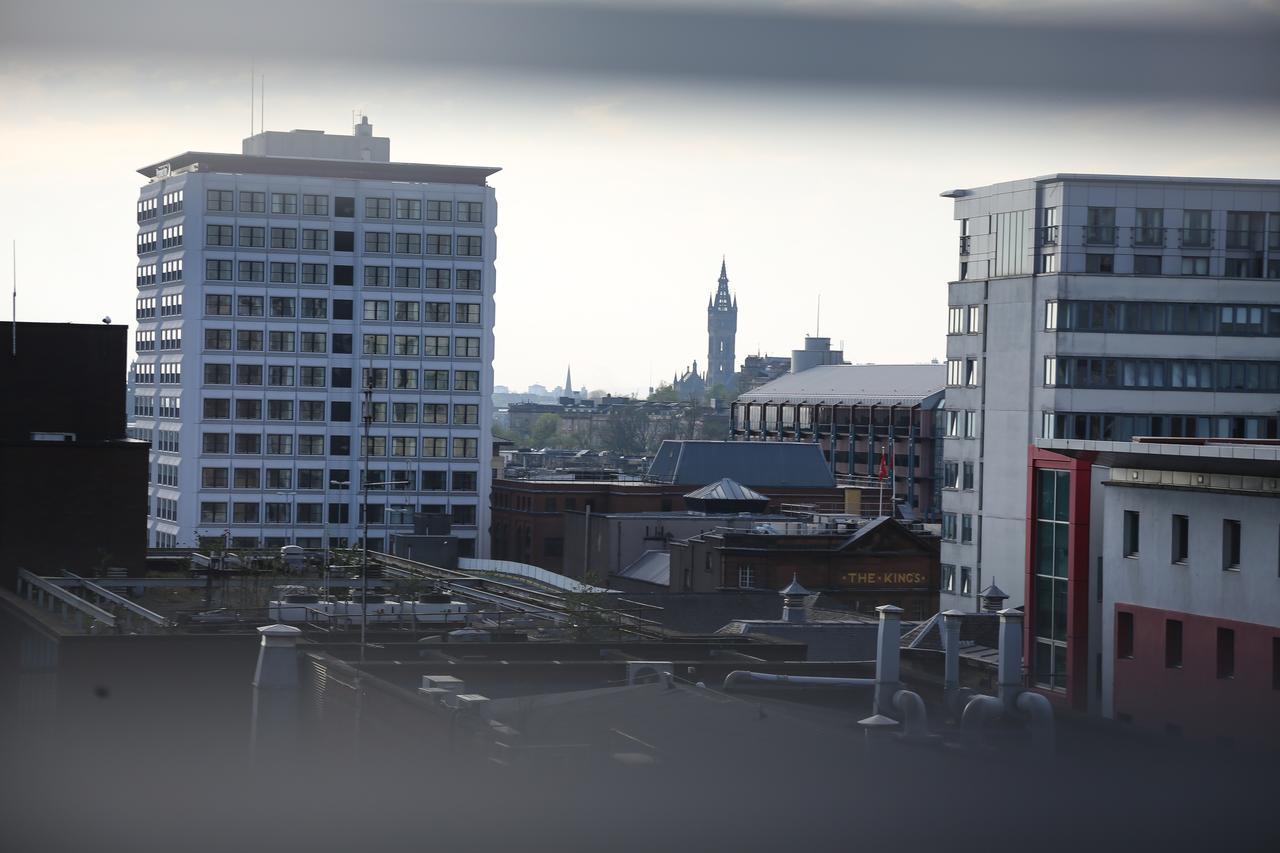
0, 0, 1280, 103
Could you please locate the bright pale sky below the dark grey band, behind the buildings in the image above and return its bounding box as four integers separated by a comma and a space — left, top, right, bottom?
0, 3, 1280, 393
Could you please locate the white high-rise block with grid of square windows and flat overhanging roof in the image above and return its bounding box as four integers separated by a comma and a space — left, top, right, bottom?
133, 119, 497, 556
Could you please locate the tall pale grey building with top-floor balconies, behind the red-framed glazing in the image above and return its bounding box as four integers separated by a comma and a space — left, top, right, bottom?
942, 174, 1280, 689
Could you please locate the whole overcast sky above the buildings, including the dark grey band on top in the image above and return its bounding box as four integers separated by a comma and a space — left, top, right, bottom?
0, 0, 1280, 393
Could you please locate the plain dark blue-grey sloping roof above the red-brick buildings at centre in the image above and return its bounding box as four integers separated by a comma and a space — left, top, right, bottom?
645, 441, 836, 489
